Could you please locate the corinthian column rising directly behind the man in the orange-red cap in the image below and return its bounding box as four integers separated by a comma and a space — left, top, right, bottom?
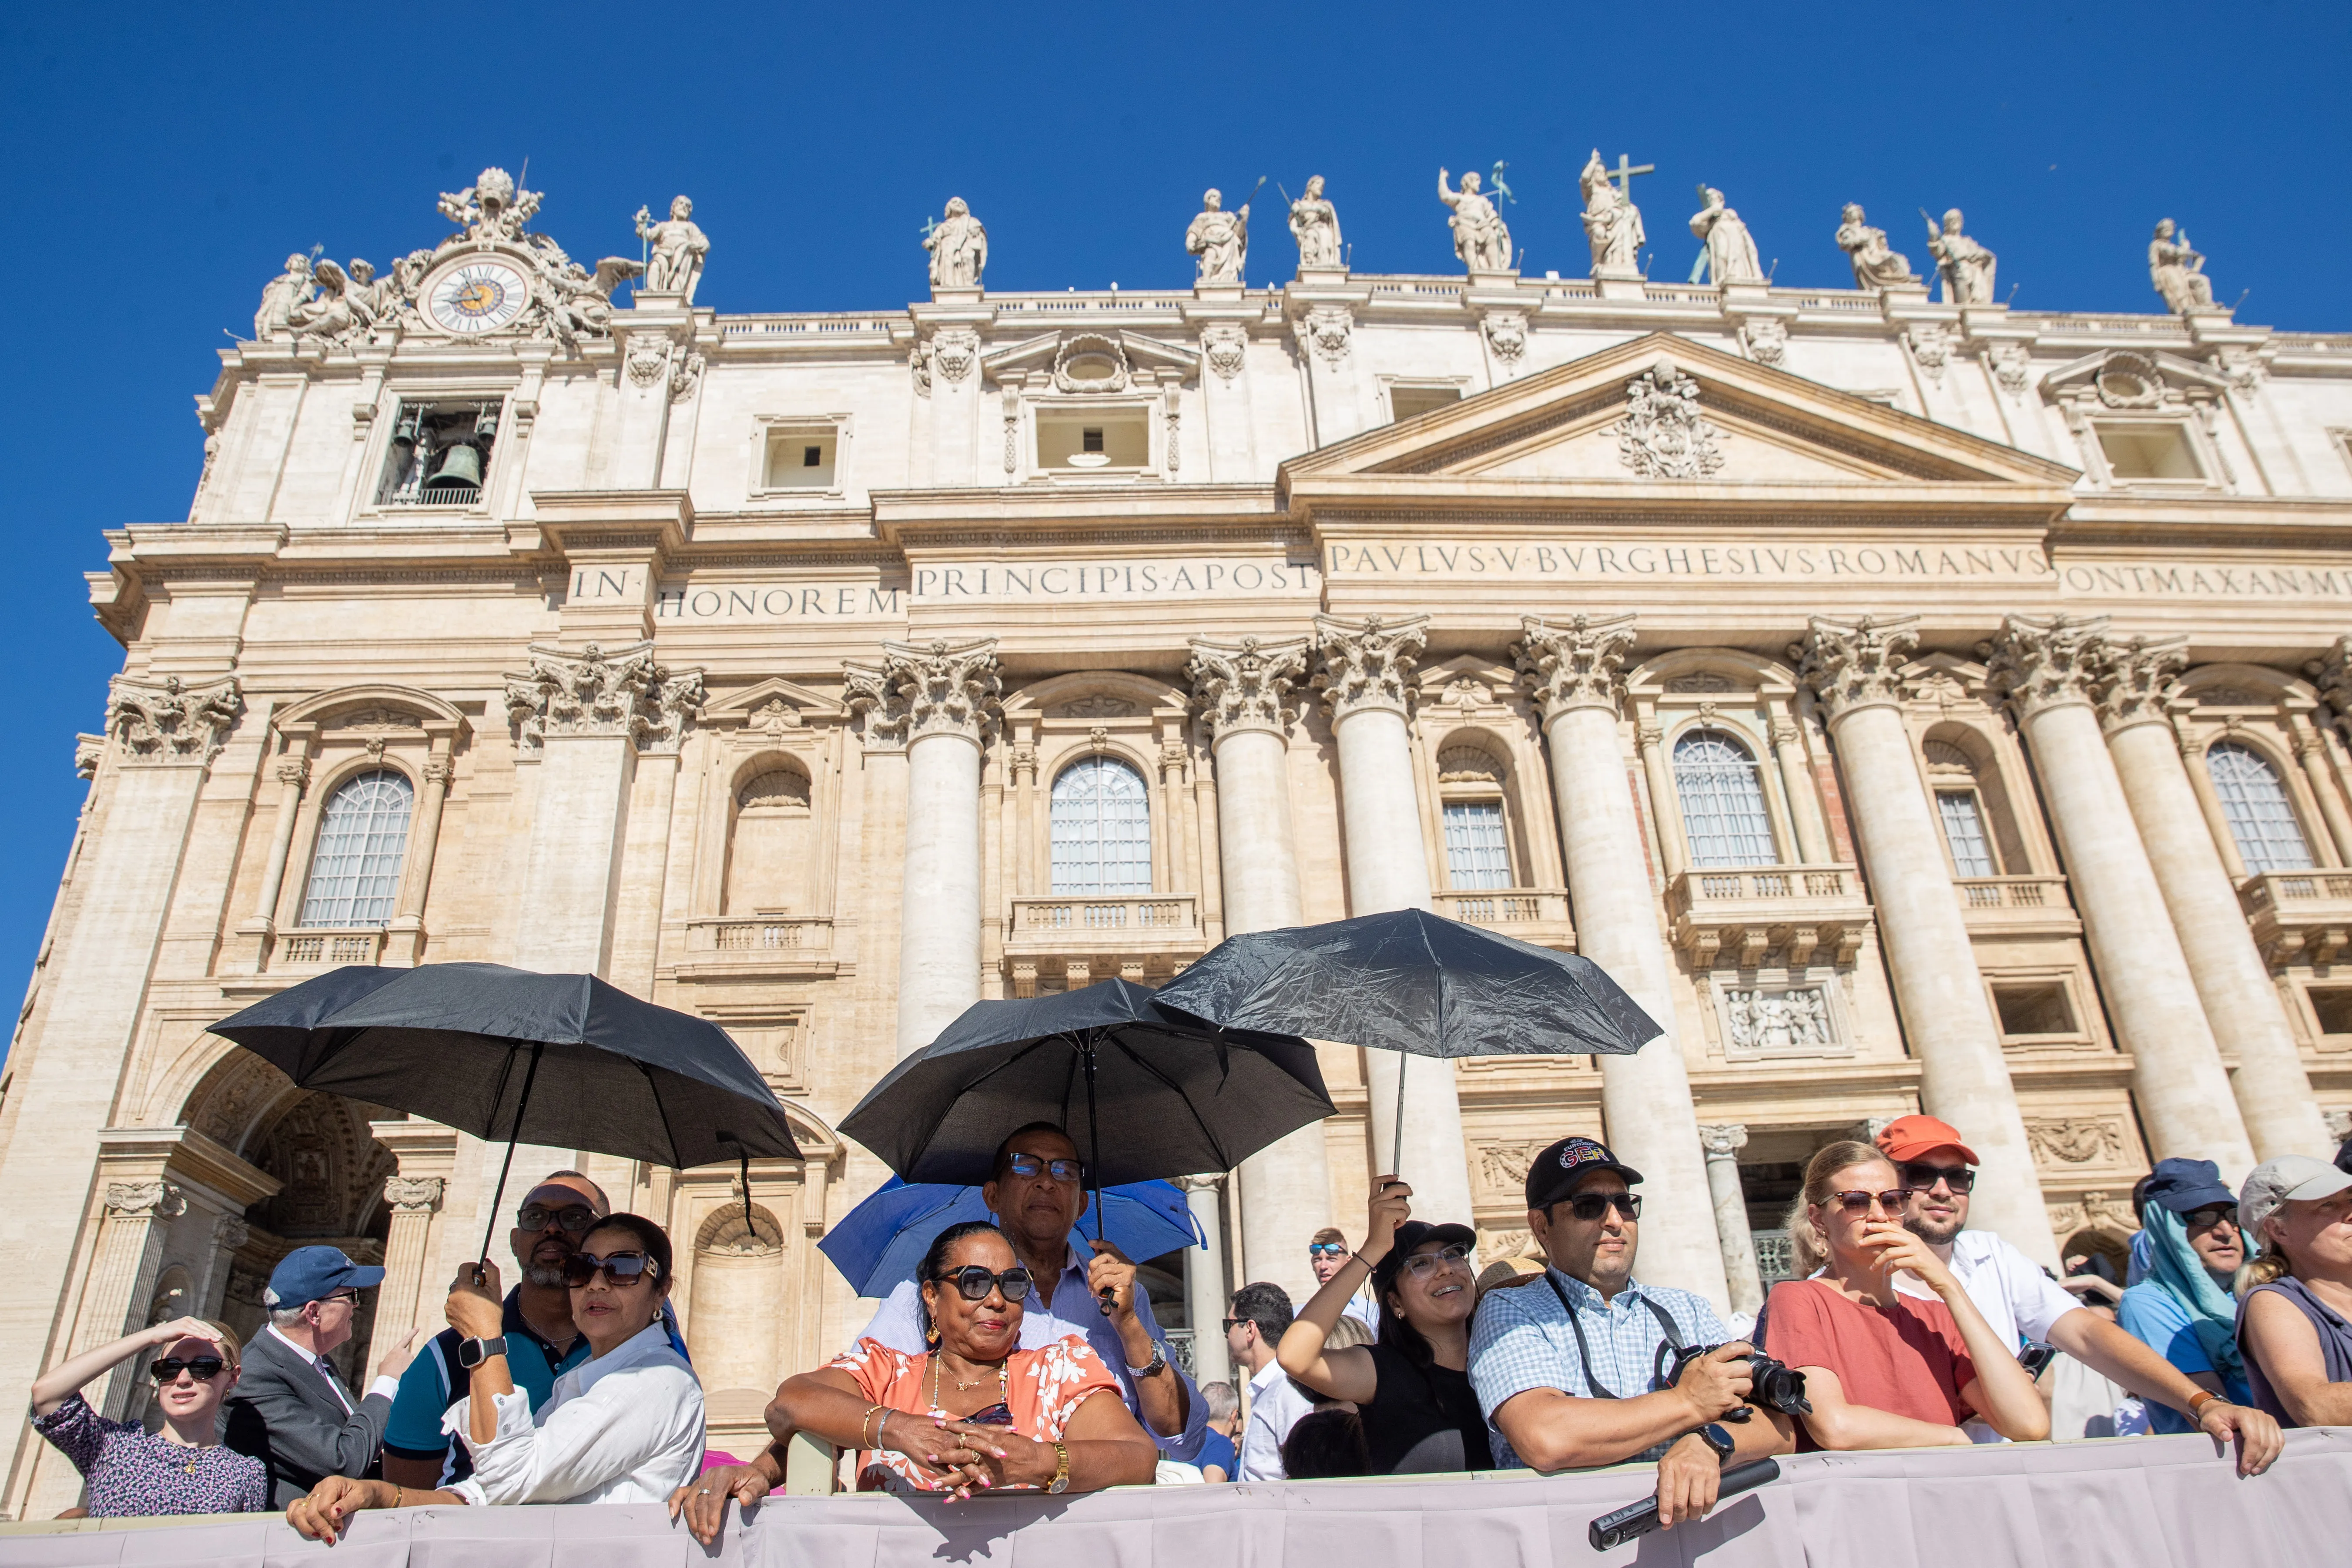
1790, 616, 2058, 1267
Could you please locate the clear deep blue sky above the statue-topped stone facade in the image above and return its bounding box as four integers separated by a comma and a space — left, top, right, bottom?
0, 0, 2352, 995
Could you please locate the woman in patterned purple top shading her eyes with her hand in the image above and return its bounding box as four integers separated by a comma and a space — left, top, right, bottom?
33, 1317, 271, 1519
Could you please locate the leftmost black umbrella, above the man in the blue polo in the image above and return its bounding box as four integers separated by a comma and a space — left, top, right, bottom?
212, 964, 800, 1258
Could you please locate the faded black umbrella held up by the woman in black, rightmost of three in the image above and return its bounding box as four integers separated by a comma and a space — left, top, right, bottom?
1155, 910, 1665, 1168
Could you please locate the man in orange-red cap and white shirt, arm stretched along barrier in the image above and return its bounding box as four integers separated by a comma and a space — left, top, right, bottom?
1877, 1117, 2286, 1476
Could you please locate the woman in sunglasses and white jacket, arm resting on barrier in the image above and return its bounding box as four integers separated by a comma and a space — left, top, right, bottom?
287, 1213, 703, 1542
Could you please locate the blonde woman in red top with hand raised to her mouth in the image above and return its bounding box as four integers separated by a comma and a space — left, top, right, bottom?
1764, 1142, 2051, 1451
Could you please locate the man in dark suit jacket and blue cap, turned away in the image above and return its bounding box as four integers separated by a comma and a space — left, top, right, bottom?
221, 1246, 419, 1507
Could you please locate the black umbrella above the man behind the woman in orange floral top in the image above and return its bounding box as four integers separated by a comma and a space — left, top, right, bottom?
842, 980, 1331, 1232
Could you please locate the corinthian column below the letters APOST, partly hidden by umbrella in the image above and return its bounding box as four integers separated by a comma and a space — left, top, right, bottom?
1186, 637, 1326, 1297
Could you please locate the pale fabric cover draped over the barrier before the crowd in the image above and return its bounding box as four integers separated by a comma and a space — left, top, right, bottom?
0, 1427, 2352, 1568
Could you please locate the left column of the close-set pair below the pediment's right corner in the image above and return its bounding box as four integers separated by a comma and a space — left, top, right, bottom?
1985, 616, 2277, 1187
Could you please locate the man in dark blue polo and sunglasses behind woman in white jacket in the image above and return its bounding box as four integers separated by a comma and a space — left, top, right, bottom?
383, 1171, 612, 1488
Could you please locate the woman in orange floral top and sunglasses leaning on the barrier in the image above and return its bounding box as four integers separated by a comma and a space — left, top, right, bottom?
767, 1223, 1159, 1498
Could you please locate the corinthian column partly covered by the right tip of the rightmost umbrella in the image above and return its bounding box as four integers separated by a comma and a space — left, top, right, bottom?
1512, 616, 1731, 1310
